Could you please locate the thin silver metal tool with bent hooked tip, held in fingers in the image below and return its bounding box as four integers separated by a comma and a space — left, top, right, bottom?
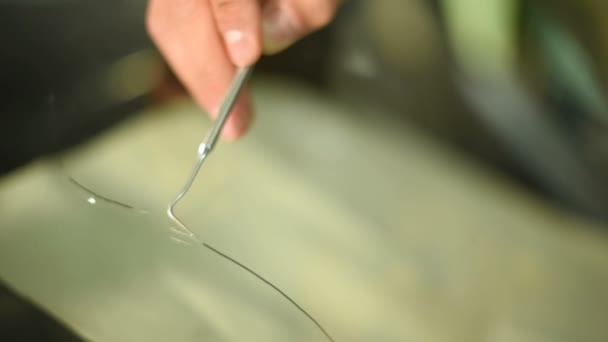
167, 67, 253, 238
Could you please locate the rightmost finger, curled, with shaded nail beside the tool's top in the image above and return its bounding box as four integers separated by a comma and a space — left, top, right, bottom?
262, 0, 340, 54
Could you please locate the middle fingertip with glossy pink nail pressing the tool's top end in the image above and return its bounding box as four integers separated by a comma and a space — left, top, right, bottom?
211, 0, 262, 67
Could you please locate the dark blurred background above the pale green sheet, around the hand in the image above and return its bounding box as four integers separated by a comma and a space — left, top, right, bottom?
0, 0, 608, 340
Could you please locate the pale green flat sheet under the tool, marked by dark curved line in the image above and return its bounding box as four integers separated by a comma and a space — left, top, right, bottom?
0, 79, 608, 341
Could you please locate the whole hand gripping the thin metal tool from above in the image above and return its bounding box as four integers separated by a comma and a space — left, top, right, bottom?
147, 0, 339, 140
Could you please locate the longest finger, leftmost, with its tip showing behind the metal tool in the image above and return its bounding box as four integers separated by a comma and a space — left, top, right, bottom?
147, 0, 252, 139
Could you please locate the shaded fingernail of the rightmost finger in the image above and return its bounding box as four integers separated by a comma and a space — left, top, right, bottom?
262, 5, 299, 54
